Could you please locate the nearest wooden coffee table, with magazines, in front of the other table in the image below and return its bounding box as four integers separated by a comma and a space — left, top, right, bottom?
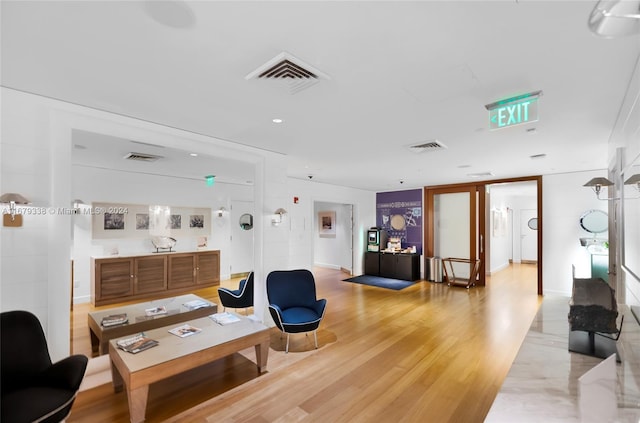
109, 316, 270, 423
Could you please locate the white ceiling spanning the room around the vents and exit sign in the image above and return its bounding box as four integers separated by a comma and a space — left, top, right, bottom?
1, 0, 640, 191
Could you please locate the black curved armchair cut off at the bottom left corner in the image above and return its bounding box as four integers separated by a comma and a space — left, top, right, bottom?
0, 310, 89, 423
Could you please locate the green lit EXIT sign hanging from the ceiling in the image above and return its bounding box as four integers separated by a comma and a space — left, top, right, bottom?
485, 91, 542, 129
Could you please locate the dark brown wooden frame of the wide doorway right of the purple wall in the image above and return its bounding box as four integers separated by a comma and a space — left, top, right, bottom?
423, 175, 544, 295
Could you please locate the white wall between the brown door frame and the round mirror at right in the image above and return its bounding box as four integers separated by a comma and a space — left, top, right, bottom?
542, 170, 608, 296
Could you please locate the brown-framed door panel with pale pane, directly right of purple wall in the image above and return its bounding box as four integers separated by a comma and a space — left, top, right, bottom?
425, 185, 485, 287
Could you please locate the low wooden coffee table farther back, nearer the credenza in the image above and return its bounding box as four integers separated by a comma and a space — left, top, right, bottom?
87, 294, 218, 356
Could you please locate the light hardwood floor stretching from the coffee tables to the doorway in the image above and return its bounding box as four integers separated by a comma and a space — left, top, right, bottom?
67, 264, 542, 423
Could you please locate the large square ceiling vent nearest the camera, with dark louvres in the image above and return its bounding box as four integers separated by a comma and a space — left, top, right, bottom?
245, 52, 331, 94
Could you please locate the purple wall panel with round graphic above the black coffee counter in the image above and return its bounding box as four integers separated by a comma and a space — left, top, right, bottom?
376, 189, 422, 254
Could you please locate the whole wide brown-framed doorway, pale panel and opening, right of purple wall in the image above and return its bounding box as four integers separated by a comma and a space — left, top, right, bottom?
424, 176, 543, 295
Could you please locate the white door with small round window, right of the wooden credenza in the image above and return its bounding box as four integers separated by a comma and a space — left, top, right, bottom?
230, 201, 254, 275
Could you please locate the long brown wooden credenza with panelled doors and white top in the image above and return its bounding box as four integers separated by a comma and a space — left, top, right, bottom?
91, 250, 220, 306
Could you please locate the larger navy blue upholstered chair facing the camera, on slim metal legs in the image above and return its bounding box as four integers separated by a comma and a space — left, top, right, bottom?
267, 269, 327, 353
